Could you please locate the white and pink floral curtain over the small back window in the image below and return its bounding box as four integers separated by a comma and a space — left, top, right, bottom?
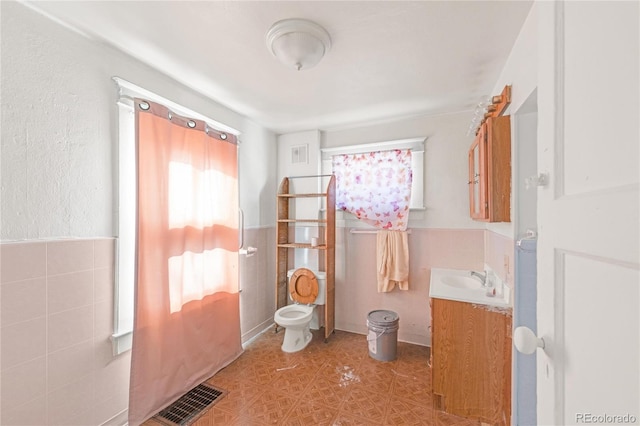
332, 149, 412, 231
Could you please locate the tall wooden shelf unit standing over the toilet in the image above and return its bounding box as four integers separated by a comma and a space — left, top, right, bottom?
276, 176, 336, 341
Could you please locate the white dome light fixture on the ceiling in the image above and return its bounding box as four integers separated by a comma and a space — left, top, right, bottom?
267, 19, 331, 71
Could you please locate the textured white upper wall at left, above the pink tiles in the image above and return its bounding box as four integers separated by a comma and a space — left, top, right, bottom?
0, 3, 118, 239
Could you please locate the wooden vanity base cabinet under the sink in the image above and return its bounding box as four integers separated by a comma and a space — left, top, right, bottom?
430, 298, 512, 425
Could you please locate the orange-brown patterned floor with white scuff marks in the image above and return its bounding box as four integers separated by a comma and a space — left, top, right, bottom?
144, 329, 479, 426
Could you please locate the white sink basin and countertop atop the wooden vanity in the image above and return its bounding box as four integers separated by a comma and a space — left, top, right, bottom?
429, 268, 511, 308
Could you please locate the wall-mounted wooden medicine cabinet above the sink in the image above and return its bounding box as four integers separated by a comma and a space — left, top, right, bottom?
468, 116, 511, 222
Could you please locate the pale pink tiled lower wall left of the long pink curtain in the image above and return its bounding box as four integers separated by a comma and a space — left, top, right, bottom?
0, 238, 130, 425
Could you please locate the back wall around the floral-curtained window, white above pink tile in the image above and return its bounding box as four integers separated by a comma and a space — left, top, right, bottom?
278, 112, 485, 345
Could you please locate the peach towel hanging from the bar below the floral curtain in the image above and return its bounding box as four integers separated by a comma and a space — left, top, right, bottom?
376, 230, 409, 293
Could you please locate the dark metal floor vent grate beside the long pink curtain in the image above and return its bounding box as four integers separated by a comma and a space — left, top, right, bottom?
153, 383, 227, 426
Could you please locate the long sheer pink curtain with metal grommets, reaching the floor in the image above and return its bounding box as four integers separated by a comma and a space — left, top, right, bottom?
129, 99, 242, 425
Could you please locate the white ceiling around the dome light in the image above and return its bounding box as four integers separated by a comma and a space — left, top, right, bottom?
28, 0, 532, 133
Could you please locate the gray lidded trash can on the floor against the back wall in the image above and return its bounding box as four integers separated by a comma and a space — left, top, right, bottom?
367, 310, 400, 361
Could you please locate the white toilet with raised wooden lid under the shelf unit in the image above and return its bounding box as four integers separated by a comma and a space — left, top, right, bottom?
273, 268, 326, 352
